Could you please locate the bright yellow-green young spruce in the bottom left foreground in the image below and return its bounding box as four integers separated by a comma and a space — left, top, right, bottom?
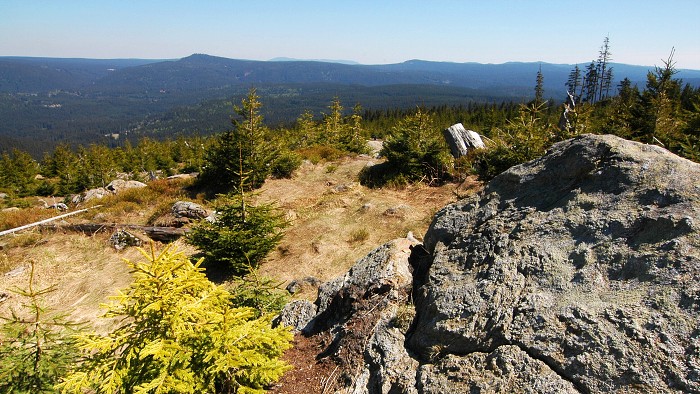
58, 248, 292, 393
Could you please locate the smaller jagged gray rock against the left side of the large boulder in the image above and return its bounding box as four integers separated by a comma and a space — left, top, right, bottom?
288, 239, 418, 394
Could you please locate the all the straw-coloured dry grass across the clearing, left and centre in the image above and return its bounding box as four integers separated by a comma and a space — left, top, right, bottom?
0, 156, 478, 330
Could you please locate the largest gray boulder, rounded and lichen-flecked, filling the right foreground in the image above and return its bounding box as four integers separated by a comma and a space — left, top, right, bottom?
408, 135, 700, 392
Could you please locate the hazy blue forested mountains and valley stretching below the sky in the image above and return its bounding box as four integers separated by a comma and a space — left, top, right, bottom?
0, 54, 700, 155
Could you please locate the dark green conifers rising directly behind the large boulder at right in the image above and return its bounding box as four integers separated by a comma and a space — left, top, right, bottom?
468, 43, 700, 179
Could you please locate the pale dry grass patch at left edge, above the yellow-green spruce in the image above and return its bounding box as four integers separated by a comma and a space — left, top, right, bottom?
0, 233, 197, 332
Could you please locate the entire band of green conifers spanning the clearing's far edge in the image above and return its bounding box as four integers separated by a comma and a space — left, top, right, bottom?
0, 39, 700, 200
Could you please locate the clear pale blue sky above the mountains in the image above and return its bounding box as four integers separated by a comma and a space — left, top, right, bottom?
0, 0, 700, 69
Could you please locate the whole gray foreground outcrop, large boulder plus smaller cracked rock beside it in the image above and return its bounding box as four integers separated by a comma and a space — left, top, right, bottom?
284, 135, 700, 393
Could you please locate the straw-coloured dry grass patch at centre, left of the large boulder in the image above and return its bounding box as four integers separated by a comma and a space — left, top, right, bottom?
259, 156, 478, 288
